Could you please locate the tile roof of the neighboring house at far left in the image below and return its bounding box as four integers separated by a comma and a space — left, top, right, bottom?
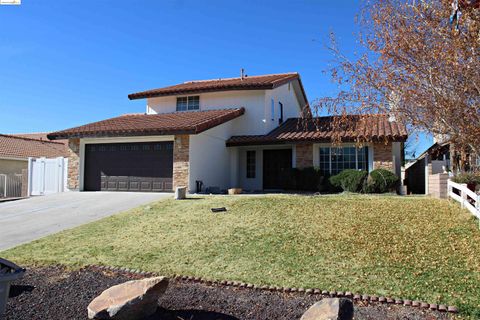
0, 134, 67, 158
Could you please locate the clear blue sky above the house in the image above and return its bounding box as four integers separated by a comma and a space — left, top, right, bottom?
0, 0, 431, 158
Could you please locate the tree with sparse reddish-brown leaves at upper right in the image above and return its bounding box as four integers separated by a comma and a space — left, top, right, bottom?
312, 0, 480, 168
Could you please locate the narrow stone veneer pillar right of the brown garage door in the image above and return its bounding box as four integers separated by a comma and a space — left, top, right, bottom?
173, 135, 190, 190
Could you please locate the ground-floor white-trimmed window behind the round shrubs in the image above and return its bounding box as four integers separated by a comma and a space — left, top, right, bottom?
319, 146, 368, 175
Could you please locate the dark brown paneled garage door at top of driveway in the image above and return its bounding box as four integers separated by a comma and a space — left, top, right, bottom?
84, 142, 173, 192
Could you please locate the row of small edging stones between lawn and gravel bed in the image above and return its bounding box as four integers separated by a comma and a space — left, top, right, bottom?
84, 264, 458, 313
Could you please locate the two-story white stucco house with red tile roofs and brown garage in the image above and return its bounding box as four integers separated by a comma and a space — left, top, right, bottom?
48, 73, 407, 192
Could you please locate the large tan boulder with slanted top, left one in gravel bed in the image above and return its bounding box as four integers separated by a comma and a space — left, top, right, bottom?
88, 277, 168, 320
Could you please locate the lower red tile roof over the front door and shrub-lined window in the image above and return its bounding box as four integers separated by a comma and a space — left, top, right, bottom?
227, 115, 408, 146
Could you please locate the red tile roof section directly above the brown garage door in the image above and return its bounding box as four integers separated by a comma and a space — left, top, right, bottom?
48, 108, 245, 140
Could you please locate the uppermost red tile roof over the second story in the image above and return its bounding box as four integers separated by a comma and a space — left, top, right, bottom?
128, 72, 308, 101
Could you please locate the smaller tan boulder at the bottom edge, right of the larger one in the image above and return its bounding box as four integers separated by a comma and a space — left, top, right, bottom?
300, 298, 353, 320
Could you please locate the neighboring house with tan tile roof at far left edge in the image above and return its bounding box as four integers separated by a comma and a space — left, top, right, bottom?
0, 134, 67, 174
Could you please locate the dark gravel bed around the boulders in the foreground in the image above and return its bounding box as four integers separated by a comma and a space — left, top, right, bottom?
6, 267, 449, 320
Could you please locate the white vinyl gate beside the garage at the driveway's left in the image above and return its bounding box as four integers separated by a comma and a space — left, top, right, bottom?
28, 157, 68, 196
